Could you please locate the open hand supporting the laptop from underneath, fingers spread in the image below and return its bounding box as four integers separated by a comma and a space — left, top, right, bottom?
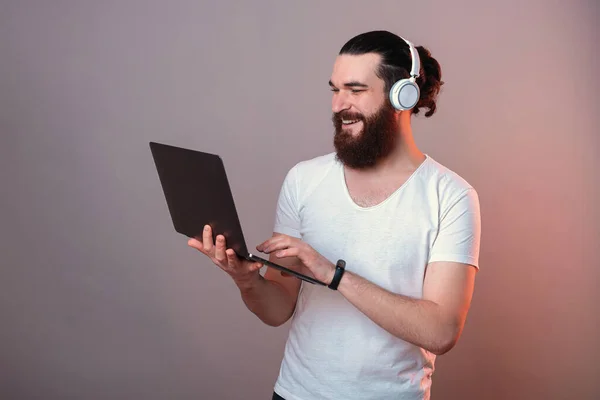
188, 225, 262, 288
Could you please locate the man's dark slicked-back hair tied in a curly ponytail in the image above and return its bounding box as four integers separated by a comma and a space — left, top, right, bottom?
339, 31, 444, 117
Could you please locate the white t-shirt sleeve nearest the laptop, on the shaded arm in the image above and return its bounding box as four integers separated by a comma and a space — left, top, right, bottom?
273, 167, 301, 238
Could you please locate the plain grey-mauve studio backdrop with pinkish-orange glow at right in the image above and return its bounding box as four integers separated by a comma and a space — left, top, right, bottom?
0, 0, 600, 400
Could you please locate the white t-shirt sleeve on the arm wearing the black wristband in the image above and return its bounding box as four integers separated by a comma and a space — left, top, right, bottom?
429, 188, 481, 268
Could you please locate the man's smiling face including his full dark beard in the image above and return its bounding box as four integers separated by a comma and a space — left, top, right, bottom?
330, 54, 398, 168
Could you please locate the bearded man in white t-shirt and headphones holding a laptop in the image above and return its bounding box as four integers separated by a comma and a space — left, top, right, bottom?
189, 31, 480, 400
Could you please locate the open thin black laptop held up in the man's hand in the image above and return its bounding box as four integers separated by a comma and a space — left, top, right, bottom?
150, 142, 327, 286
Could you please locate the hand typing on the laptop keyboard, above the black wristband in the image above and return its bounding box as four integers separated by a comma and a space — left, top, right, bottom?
256, 235, 335, 284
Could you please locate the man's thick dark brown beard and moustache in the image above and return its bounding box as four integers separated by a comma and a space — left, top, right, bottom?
332, 103, 398, 169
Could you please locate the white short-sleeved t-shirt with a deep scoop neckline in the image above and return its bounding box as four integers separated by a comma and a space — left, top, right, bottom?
274, 153, 480, 400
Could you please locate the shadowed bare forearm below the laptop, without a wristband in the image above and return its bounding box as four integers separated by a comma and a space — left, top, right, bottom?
237, 273, 295, 326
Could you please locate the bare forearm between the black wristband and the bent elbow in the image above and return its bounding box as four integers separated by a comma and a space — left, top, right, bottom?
338, 271, 456, 354
